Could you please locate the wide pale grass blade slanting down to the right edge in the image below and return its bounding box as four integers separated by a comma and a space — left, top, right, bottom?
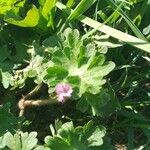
56, 2, 150, 53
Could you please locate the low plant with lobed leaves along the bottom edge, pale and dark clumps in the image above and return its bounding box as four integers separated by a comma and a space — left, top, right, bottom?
0, 122, 106, 150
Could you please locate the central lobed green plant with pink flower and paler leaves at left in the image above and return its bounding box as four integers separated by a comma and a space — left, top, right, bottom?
8, 28, 115, 115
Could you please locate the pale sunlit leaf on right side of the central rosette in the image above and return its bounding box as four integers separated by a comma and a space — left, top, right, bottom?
77, 62, 115, 95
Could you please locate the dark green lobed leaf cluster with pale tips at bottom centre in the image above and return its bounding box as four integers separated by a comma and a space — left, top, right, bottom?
45, 121, 106, 150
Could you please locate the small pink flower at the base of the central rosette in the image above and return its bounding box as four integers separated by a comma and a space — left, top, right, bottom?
55, 83, 73, 103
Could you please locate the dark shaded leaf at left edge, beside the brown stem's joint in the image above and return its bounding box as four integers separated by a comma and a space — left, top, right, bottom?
0, 104, 22, 136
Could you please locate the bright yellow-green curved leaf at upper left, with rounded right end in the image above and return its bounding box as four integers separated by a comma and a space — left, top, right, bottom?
4, 6, 39, 27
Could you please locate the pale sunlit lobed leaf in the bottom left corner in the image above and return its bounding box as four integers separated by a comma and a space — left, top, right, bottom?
3, 132, 38, 150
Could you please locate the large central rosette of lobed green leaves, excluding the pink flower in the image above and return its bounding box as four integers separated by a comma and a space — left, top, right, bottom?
44, 28, 115, 97
